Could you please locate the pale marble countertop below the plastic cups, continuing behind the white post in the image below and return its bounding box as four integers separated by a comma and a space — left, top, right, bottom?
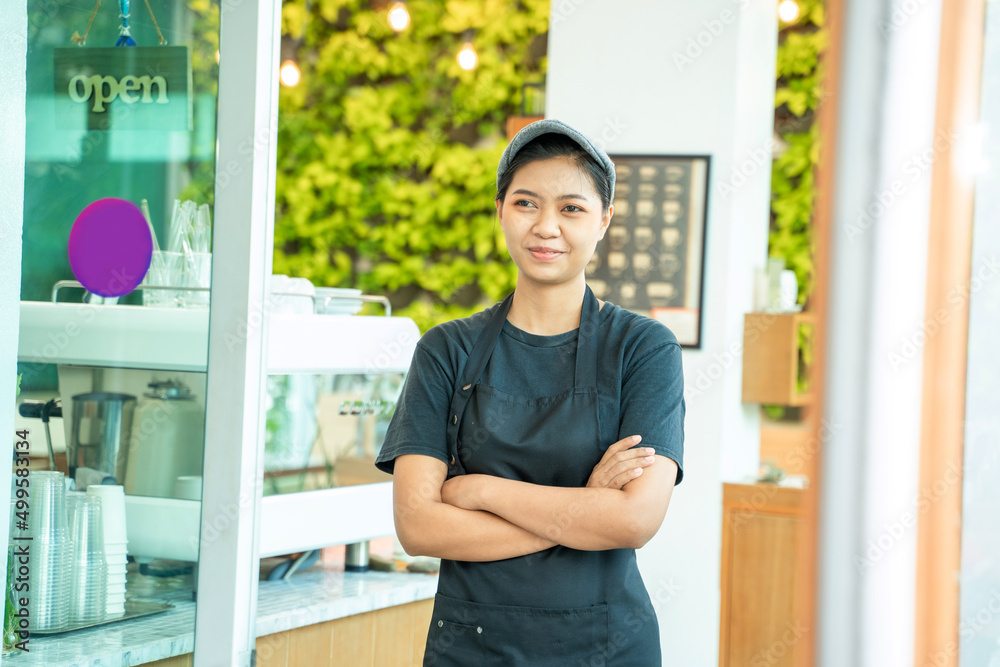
3, 565, 437, 667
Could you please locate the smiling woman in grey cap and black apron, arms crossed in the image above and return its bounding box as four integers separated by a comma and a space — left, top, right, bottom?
377, 120, 684, 667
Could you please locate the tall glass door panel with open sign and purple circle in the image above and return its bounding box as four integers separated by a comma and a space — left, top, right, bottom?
6, 0, 228, 665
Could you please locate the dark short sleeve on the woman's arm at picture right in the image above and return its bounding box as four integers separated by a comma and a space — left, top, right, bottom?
618, 334, 685, 484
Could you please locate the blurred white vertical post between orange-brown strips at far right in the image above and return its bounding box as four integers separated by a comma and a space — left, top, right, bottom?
817, 0, 941, 667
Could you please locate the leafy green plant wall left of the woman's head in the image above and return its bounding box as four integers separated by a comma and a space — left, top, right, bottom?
274, 0, 549, 330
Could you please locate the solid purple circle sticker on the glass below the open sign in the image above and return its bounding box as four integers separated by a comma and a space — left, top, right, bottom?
69, 197, 153, 297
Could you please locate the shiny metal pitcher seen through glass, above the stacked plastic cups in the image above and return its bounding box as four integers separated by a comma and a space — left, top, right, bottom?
66, 392, 135, 484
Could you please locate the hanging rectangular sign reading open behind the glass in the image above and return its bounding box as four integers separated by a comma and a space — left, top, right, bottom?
53, 46, 192, 130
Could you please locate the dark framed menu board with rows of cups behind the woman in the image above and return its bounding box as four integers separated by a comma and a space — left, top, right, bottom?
587, 155, 710, 348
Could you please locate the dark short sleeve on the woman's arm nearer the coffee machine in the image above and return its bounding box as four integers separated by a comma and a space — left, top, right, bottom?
375, 332, 455, 474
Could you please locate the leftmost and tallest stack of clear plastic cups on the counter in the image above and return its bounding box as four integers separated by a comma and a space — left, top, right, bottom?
26, 470, 73, 631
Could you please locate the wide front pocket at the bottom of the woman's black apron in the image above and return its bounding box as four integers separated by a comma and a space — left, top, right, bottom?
424, 594, 609, 667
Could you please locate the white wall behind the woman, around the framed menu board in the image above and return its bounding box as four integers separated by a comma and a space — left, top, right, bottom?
546, 0, 777, 667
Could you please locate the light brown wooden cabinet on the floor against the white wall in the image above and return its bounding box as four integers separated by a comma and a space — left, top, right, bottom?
719, 484, 811, 667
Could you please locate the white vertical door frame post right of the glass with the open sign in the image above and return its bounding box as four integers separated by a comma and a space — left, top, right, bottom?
194, 0, 281, 667
